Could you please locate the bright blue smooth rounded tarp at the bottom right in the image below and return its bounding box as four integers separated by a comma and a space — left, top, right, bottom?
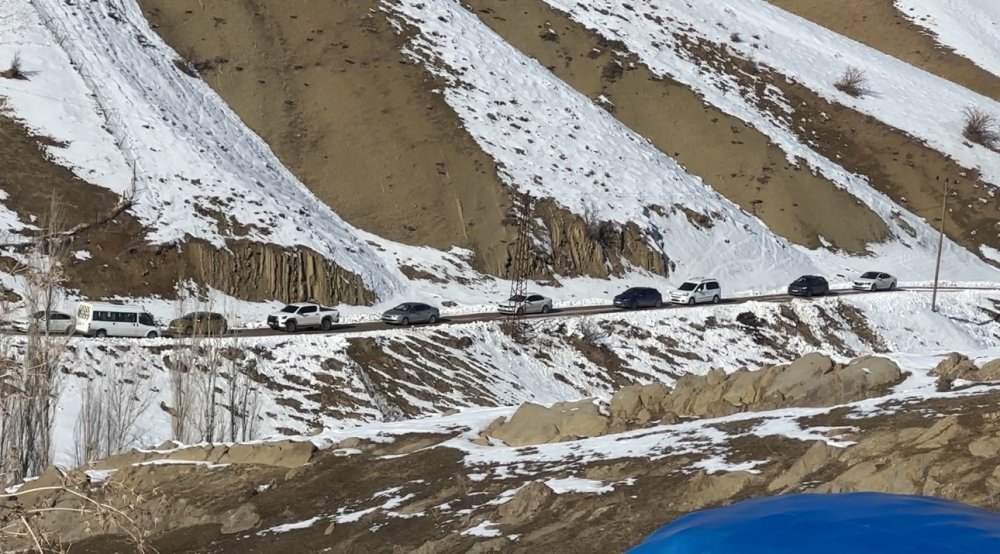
629, 493, 1000, 554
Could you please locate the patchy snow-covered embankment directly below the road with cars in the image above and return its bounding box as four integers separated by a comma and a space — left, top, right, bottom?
48, 291, 998, 464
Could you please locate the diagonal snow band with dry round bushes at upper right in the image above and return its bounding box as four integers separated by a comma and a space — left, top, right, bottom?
545, 0, 1000, 181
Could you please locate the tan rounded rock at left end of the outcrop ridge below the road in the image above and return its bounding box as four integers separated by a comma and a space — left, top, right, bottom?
482, 400, 609, 446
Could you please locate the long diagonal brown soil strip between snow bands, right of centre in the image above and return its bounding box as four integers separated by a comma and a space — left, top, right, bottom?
469, 0, 887, 252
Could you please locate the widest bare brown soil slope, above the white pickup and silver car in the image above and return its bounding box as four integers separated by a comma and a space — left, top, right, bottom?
140, 0, 512, 273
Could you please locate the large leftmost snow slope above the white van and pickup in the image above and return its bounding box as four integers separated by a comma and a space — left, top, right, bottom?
0, 0, 402, 295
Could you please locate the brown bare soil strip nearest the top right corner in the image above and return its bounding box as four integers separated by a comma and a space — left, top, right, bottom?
768, 0, 1000, 100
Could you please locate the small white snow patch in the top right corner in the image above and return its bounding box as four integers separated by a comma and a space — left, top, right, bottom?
894, 0, 1000, 75
